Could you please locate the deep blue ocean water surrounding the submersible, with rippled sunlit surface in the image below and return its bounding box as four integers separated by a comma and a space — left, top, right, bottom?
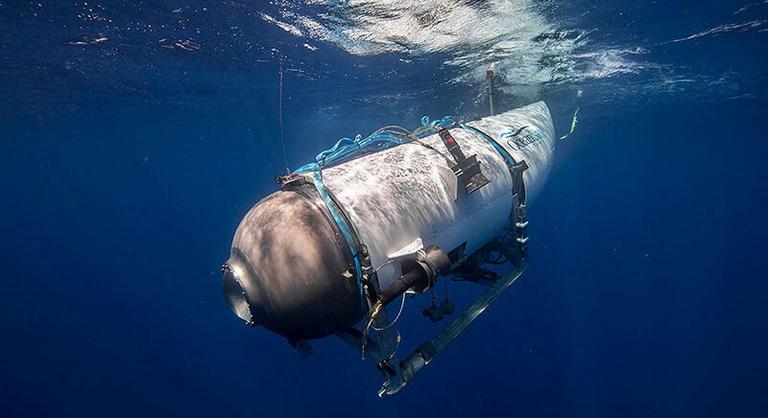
0, 0, 768, 418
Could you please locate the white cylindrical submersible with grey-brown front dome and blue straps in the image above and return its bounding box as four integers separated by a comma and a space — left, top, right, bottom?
223, 102, 555, 396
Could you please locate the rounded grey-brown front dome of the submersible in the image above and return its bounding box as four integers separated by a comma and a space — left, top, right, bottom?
223, 189, 363, 340
